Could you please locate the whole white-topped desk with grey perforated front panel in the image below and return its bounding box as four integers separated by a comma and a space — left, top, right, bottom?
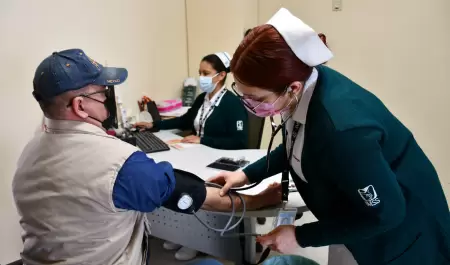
148, 131, 307, 264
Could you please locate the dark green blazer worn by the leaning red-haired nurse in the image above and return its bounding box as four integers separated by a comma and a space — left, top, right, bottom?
244, 66, 450, 265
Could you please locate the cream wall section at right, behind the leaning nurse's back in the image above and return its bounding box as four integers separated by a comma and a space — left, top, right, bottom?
259, 0, 450, 200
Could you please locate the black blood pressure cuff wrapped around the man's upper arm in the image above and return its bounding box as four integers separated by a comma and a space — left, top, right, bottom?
163, 169, 206, 214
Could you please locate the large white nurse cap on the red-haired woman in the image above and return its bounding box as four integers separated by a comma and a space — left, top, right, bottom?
267, 8, 333, 67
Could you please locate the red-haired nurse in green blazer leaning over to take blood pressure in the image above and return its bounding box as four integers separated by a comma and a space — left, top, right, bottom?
211, 9, 450, 265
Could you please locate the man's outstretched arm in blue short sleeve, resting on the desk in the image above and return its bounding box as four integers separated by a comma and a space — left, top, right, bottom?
112, 152, 281, 212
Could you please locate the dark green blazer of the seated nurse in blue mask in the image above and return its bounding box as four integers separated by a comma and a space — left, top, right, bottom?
154, 91, 248, 150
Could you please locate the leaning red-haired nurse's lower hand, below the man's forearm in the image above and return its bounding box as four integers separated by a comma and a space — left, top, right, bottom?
256, 225, 300, 255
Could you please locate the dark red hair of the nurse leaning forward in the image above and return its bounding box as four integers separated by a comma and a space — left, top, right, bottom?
231, 25, 312, 93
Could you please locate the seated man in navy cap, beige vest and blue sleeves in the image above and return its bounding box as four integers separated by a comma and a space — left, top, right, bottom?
13, 49, 281, 265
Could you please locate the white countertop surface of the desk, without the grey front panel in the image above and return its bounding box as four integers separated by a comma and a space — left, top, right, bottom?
148, 131, 306, 217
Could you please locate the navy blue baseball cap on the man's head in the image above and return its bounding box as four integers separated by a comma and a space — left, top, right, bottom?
33, 49, 128, 101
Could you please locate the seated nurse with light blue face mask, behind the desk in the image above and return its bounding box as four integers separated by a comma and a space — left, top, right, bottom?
135, 52, 248, 150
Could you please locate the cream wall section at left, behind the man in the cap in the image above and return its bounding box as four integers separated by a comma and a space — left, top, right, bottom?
0, 0, 188, 264
